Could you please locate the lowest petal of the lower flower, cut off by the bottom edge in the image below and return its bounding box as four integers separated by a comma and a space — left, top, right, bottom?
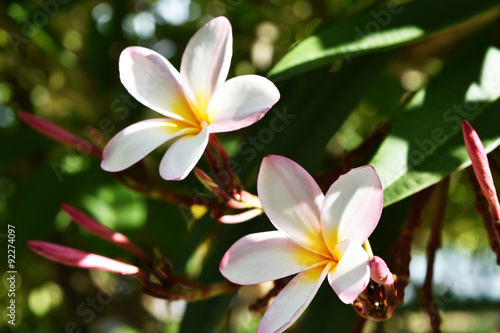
257, 264, 332, 333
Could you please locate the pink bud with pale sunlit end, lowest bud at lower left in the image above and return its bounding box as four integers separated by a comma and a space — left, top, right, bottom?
27, 241, 140, 275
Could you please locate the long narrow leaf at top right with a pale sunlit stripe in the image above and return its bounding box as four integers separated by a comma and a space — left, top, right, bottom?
268, 0, 498, 80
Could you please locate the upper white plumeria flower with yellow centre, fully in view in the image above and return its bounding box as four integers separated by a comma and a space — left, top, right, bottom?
101, 17, 280, 180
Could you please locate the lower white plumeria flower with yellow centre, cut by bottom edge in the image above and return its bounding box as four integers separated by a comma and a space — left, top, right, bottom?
220, 156, 383, 332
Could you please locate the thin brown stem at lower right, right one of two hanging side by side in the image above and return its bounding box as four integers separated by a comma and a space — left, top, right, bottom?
422, 177, 450, 333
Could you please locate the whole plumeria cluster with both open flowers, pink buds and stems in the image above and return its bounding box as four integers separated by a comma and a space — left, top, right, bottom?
24, 17, 402, 332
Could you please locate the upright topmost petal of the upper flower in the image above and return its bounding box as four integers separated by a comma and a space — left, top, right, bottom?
181, 16, 233, 116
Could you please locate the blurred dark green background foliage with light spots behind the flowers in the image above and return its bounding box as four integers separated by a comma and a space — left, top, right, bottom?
0, 0, 500, 333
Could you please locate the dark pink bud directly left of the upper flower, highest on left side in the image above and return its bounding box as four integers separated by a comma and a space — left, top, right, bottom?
19, 111, 102, 158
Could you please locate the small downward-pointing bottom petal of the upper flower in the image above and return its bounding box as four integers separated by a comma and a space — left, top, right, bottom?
160, 123, 209, 180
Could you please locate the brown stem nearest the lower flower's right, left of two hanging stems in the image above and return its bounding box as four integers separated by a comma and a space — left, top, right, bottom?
396, 186, 434, 304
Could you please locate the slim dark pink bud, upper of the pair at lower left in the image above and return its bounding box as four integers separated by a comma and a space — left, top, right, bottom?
61, 203, 149, 262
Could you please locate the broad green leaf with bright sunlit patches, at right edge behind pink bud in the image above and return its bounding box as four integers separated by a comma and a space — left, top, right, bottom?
370, 29, 500, 206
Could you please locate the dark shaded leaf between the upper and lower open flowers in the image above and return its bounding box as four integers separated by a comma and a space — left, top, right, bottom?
236, 52, 393, 184
